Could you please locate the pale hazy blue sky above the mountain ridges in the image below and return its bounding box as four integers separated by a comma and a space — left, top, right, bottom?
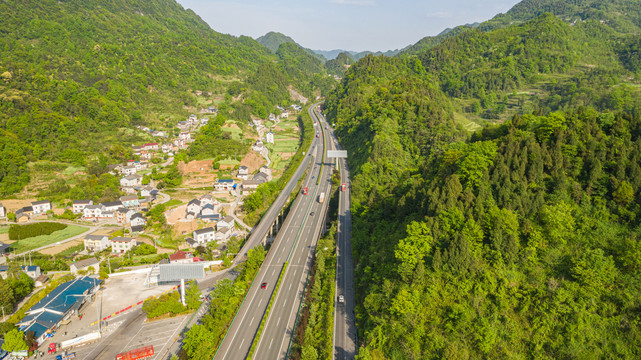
177, 0, 519, 51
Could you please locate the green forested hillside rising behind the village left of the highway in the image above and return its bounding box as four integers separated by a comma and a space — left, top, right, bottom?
0, 0, 273, 194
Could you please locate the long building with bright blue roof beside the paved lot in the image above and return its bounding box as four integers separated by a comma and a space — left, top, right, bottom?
18, 276, 102, 344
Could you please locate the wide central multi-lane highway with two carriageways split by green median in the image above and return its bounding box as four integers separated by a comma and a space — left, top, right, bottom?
214, 104, 331, 360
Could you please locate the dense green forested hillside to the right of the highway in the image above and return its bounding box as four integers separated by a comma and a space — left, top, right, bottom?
324, 1, 641, 359
